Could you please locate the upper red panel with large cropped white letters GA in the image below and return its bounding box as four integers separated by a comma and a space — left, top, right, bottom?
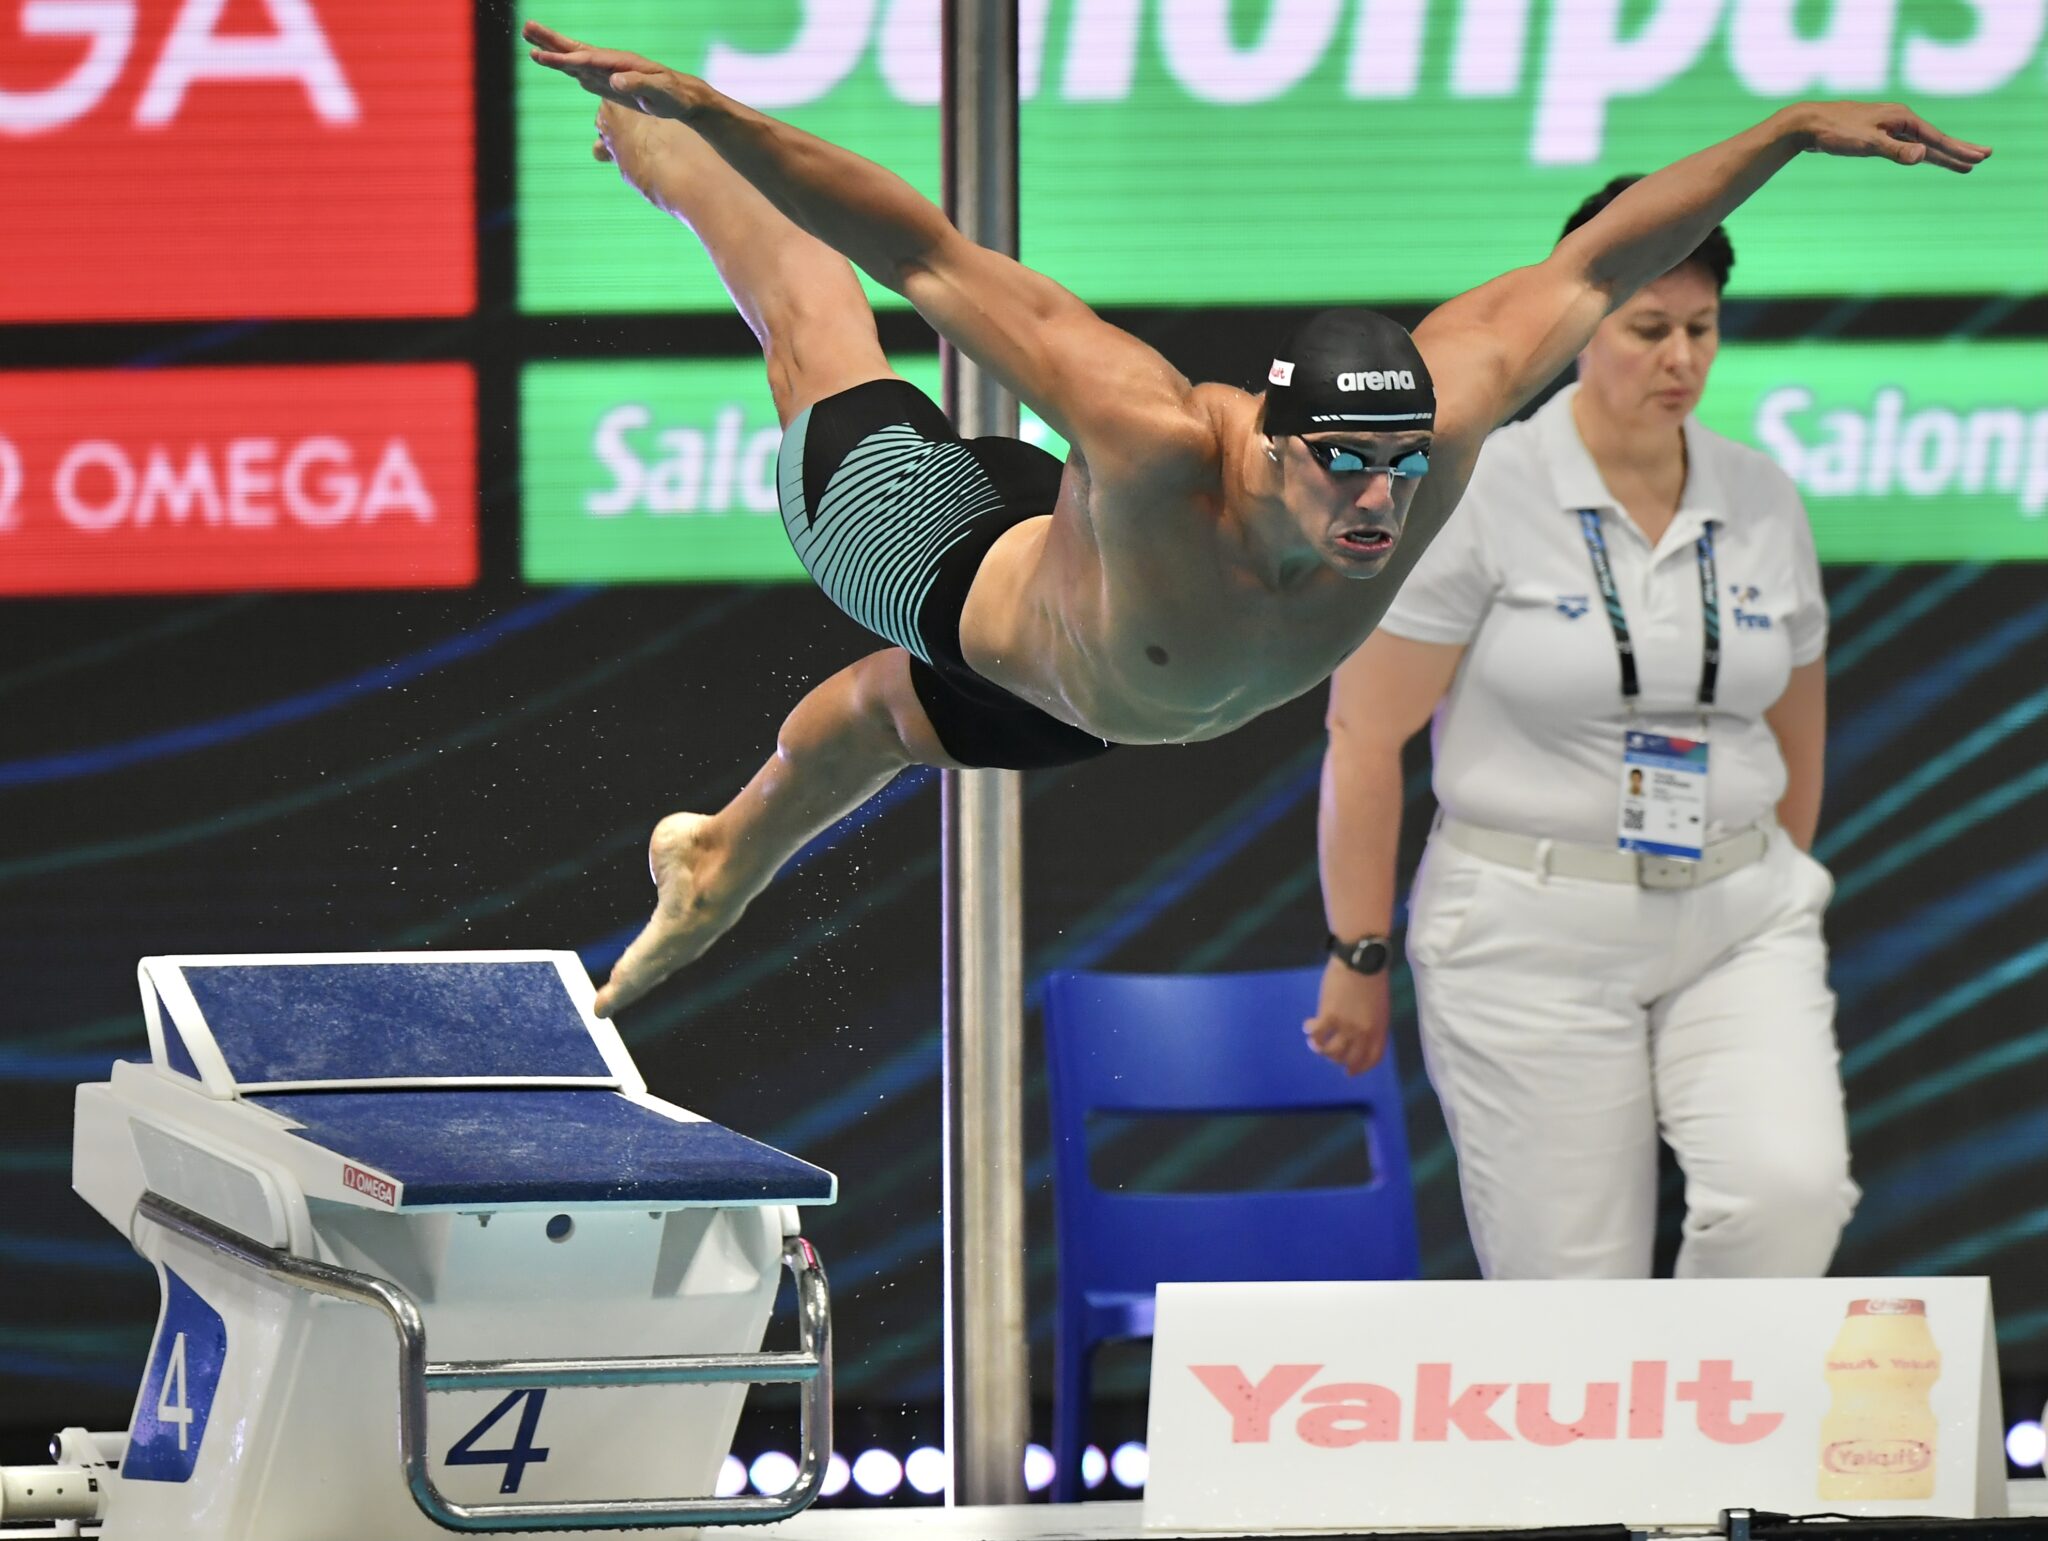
0, 0, 477, 322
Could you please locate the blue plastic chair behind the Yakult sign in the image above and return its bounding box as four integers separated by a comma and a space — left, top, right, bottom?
1044, 967, 1421, 1502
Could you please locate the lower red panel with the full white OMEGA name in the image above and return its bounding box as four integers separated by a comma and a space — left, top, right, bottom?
0, 365, 477, 594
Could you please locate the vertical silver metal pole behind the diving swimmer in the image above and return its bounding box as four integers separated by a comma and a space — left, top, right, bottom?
940, 0, 1030, 1504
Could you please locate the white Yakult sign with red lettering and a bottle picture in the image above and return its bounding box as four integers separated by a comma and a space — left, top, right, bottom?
1145, 1279, 2005, 1533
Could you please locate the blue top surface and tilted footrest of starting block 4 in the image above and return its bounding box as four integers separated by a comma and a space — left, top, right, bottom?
139, 953, 836, 1209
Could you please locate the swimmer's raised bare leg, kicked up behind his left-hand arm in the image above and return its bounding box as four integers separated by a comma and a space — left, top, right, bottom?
594, 102, 895, 428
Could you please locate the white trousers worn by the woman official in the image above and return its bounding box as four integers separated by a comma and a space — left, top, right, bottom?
1407, 826, 1860, 1279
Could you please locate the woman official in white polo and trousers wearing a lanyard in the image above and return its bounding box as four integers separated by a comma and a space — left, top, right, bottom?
1307, 178, 1858, 1279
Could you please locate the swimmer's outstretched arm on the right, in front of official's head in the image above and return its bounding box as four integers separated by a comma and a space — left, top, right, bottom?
1415, 102, 1991, 436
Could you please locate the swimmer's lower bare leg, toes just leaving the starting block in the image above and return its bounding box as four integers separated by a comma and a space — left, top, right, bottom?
596, 648, 958, 1016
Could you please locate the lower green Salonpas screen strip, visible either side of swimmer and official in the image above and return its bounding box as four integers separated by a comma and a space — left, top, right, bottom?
520, 342, 2048, 584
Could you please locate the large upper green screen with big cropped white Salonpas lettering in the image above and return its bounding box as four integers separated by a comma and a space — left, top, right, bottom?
516, 0, 2048, 311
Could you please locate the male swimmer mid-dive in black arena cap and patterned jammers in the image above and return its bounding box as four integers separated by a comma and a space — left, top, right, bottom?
524, 23, 1991, 1014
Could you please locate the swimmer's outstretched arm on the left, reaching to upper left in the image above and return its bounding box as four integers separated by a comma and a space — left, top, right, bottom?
524, 23, 1210, 475
